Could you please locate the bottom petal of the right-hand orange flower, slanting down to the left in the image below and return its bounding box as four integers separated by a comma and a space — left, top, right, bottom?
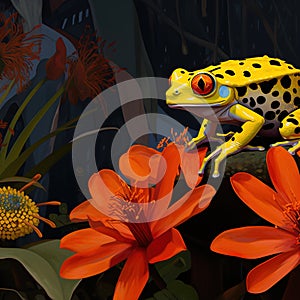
246, 250, 300, 294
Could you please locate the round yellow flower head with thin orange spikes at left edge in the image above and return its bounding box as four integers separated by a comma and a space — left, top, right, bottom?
0, 174, 60, 240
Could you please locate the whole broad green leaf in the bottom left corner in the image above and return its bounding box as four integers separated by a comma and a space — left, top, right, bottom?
0, 240, 80, 300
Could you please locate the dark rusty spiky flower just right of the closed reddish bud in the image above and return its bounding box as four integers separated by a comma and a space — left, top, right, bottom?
64, 34, 114, 104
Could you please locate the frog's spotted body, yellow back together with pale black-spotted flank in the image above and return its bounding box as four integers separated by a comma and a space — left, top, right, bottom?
200, 55, 300, 136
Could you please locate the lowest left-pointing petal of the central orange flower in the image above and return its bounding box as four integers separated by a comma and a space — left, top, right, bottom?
60, 242, 132, 279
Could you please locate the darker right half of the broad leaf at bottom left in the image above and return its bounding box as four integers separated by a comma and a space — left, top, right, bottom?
28, 240, 80, 300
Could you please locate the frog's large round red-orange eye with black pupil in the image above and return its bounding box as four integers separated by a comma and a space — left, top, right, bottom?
191, 73, 216, 96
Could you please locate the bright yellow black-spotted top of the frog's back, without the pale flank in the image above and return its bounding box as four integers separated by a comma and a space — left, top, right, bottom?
203, 55, 300, 87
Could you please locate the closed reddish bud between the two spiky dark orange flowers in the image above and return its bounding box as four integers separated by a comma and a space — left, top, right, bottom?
46, 38, 67, 80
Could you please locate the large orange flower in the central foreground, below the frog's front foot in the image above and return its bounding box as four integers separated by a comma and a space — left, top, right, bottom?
60, 145, 215, 300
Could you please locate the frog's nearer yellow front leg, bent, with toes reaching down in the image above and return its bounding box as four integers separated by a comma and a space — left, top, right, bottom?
199, 104, 265, 177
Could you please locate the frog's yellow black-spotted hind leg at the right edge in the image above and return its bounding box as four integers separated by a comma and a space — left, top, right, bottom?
271, 109, 300, 154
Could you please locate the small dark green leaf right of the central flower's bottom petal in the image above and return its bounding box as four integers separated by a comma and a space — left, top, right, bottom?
155, 251, 191, 283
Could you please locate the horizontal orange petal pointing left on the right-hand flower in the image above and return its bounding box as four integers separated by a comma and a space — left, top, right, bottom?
210, 226, 297, 258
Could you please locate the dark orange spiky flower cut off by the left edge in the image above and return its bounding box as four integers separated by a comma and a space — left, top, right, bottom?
0, 14, 42, 92
